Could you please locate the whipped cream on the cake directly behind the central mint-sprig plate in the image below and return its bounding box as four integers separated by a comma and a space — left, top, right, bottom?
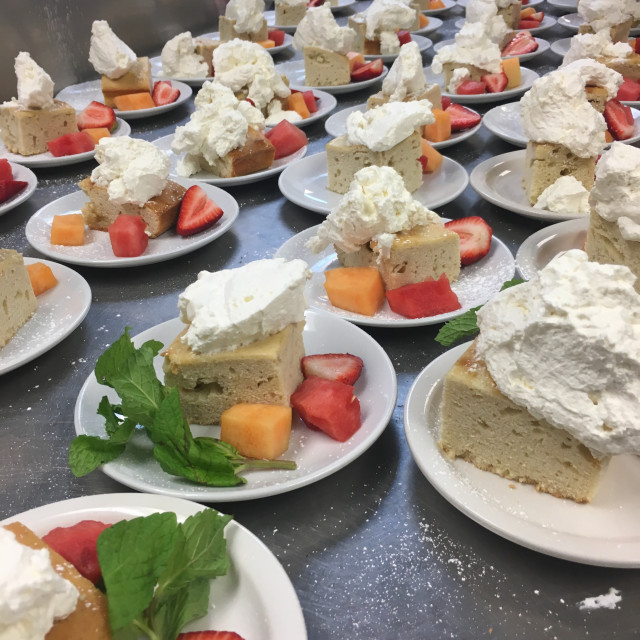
307, 166, 443, 261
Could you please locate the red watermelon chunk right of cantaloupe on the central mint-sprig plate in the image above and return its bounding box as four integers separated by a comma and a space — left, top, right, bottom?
290, 376, 361, 442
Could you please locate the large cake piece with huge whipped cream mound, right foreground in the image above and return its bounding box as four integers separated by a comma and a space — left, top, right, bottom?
439, 250, 640, 502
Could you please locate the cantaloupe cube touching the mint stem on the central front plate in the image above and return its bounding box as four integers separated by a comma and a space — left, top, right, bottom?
220, 403, 291, 460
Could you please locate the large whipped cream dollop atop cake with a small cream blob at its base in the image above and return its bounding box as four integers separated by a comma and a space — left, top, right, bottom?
520, 59, 622, 158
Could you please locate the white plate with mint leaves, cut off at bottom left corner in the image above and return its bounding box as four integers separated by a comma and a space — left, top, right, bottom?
0, 493, 307, 640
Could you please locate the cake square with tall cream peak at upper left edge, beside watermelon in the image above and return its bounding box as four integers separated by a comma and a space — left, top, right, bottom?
0, 51, 78, 156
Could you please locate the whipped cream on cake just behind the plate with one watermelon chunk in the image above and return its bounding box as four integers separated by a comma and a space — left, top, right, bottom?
213, 38, 291, 110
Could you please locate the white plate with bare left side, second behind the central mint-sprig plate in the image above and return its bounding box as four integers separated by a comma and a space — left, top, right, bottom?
278, 151, 469, 213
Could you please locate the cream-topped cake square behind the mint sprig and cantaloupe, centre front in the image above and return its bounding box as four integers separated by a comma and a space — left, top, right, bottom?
163, 259, 310, 424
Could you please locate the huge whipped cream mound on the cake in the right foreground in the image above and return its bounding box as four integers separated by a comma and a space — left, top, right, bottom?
477, 249, 640, 455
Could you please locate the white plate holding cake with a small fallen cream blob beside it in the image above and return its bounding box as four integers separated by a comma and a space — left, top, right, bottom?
471, 149, 587, 222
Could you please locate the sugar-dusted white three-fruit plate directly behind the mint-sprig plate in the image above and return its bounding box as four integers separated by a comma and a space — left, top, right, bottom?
276, 225, 515, 327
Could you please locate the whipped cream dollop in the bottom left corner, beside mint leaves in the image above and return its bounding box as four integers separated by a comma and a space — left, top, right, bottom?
0, 527, 79, 640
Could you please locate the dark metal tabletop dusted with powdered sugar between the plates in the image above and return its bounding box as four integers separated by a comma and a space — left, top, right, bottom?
0, 3, 640, 640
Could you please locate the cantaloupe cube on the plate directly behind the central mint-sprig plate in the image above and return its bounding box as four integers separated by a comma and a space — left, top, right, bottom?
324, 267, 384, 316
